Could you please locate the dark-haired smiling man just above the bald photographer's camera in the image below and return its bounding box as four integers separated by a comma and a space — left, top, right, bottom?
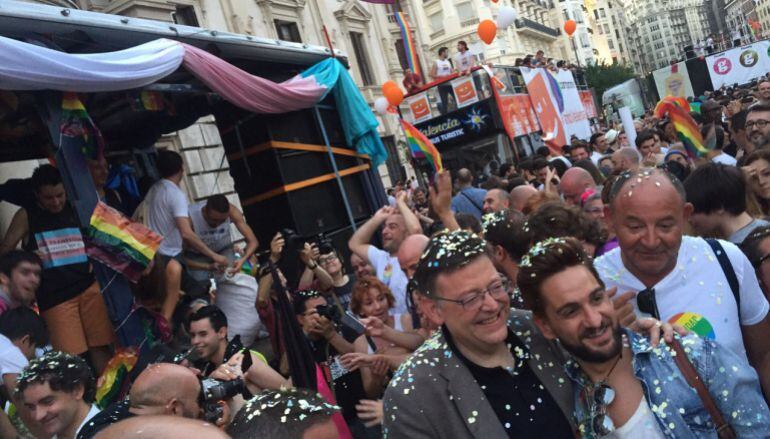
188, 305, 291, 399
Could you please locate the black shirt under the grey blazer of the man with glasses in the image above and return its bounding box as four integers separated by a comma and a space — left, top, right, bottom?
443, 327, 574, 439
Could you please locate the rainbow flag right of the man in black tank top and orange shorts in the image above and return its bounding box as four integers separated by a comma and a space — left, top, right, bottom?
85, 201, 163, 282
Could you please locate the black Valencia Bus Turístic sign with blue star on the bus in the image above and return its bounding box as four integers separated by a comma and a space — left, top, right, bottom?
415, 100, 498, 150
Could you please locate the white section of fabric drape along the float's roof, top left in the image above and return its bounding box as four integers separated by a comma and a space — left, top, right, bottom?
0, 37, 185, 92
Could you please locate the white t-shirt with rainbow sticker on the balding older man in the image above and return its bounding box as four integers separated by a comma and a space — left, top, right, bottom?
594, 236, 770, 361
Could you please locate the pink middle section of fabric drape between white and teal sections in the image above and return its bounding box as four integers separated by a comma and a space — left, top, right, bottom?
180, 43, 326, 113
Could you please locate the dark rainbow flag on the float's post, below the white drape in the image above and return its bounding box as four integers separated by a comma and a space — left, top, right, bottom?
59, 92, 104, 160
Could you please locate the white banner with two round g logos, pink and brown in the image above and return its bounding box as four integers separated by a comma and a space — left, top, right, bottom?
706, 41, 770, 90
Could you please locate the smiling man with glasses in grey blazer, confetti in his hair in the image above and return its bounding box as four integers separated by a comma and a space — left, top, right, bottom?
383, 231, 575, 438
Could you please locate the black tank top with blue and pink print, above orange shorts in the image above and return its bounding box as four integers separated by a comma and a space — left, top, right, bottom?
22, 203, 94, 311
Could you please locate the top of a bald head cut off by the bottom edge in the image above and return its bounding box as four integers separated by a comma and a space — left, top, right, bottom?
96, 415, 225, 439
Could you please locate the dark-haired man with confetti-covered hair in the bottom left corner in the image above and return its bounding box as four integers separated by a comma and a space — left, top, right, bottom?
16, 351, 99, 439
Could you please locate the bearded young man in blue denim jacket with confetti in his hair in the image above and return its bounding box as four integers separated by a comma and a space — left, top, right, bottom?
518, 238, 770, 439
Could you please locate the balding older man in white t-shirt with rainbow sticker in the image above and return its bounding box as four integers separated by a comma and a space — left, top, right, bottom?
594, 168, 770, 397
